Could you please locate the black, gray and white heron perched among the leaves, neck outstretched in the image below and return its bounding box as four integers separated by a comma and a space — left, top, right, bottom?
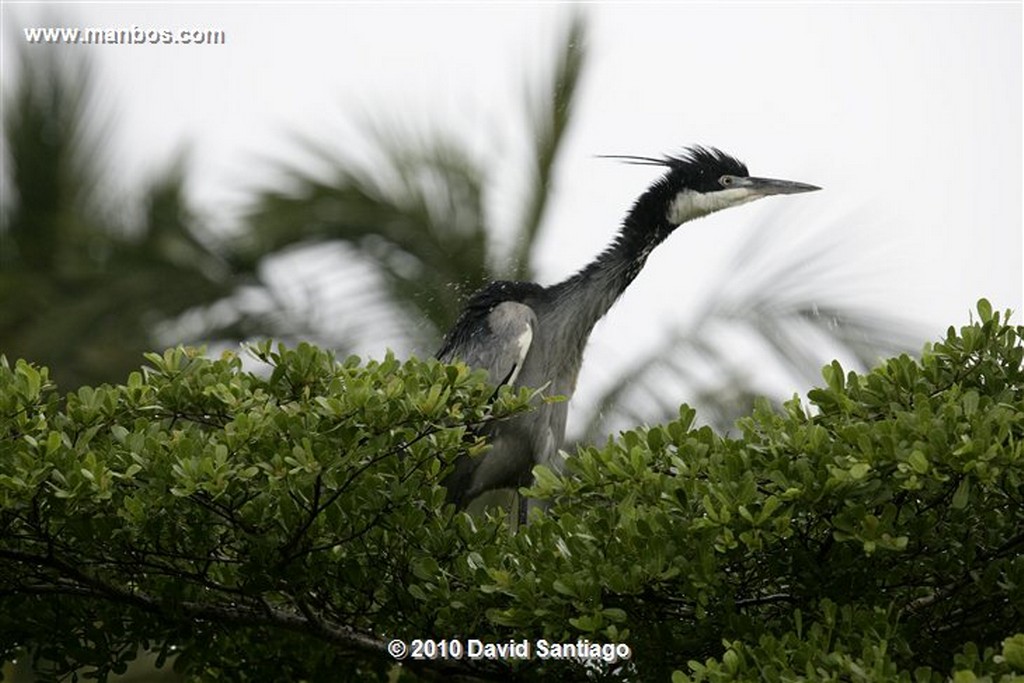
436, 145, 820, 523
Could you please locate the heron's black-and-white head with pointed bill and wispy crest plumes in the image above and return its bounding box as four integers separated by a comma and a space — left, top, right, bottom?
611, 146, 821, 227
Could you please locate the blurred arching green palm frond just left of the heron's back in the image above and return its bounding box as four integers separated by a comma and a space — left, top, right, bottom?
239, 122, 488, 344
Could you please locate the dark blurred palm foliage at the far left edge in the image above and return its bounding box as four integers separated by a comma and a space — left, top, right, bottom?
0, 46, 233, 388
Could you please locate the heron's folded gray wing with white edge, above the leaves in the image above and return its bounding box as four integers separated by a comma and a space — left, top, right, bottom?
437, 301, 537, 386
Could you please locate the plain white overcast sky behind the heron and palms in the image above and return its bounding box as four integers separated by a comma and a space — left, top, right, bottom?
0, 2, 1024, 430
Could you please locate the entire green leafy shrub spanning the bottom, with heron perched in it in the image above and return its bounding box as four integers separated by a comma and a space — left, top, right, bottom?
0, 301, 1024, 683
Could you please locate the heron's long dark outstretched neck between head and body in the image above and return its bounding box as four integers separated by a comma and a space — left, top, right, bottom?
554, 186, 677, 344
